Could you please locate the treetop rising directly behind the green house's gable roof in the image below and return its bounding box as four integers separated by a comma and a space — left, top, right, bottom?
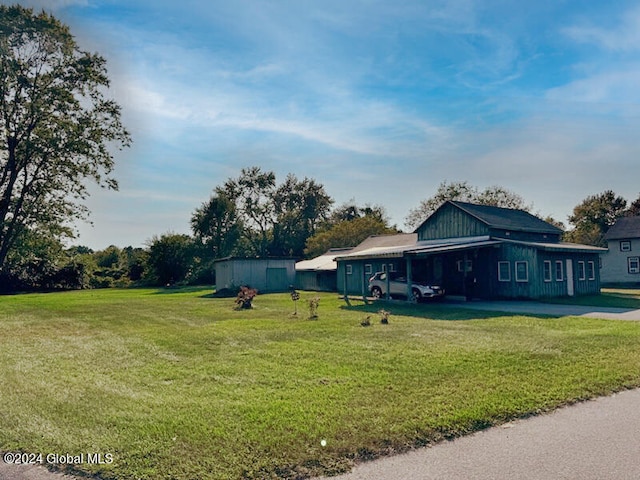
405, 181, 531, 229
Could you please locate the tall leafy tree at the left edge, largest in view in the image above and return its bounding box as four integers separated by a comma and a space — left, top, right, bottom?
0, 6, 130, 270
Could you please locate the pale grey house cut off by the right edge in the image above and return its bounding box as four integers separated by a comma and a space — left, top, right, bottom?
601, 217, 640, 284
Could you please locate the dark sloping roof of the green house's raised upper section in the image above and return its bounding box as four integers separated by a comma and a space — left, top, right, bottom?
441, 200, 562, 235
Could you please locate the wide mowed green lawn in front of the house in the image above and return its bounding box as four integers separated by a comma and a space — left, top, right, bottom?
0, 289, 640, 480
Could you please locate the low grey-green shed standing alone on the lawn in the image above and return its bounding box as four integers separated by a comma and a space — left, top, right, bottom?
213, 257, 296, 292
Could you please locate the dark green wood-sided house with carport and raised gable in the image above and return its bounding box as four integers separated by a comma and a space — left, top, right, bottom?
336, 201, 605, 299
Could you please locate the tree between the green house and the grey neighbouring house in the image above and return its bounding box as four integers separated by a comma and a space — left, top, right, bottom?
564, 190, 627, 247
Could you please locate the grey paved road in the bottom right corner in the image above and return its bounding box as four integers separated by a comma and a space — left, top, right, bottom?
320, 390, 640, 480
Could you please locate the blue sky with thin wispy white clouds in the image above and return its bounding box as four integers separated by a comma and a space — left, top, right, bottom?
5, 0, 640, 249
